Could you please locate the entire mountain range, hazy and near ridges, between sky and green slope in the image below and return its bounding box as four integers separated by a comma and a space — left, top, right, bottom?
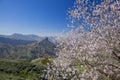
0, 34, 56, 60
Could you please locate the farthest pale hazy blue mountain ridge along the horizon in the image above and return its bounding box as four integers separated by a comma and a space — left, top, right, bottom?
0, 33, 43, 41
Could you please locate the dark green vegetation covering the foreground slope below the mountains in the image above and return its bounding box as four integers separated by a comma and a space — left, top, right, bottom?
0, 60, 45, 80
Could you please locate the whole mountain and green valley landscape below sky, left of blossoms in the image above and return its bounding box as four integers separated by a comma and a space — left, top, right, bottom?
0, 35, 56, 80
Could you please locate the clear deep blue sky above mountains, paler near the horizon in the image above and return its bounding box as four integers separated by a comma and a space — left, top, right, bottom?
0, 0, 75, 36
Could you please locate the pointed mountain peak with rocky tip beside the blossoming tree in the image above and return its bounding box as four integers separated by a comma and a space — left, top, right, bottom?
31, 38, 56, 58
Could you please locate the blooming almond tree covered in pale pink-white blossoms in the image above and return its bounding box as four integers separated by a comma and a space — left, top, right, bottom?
46, 0, 120, 80
